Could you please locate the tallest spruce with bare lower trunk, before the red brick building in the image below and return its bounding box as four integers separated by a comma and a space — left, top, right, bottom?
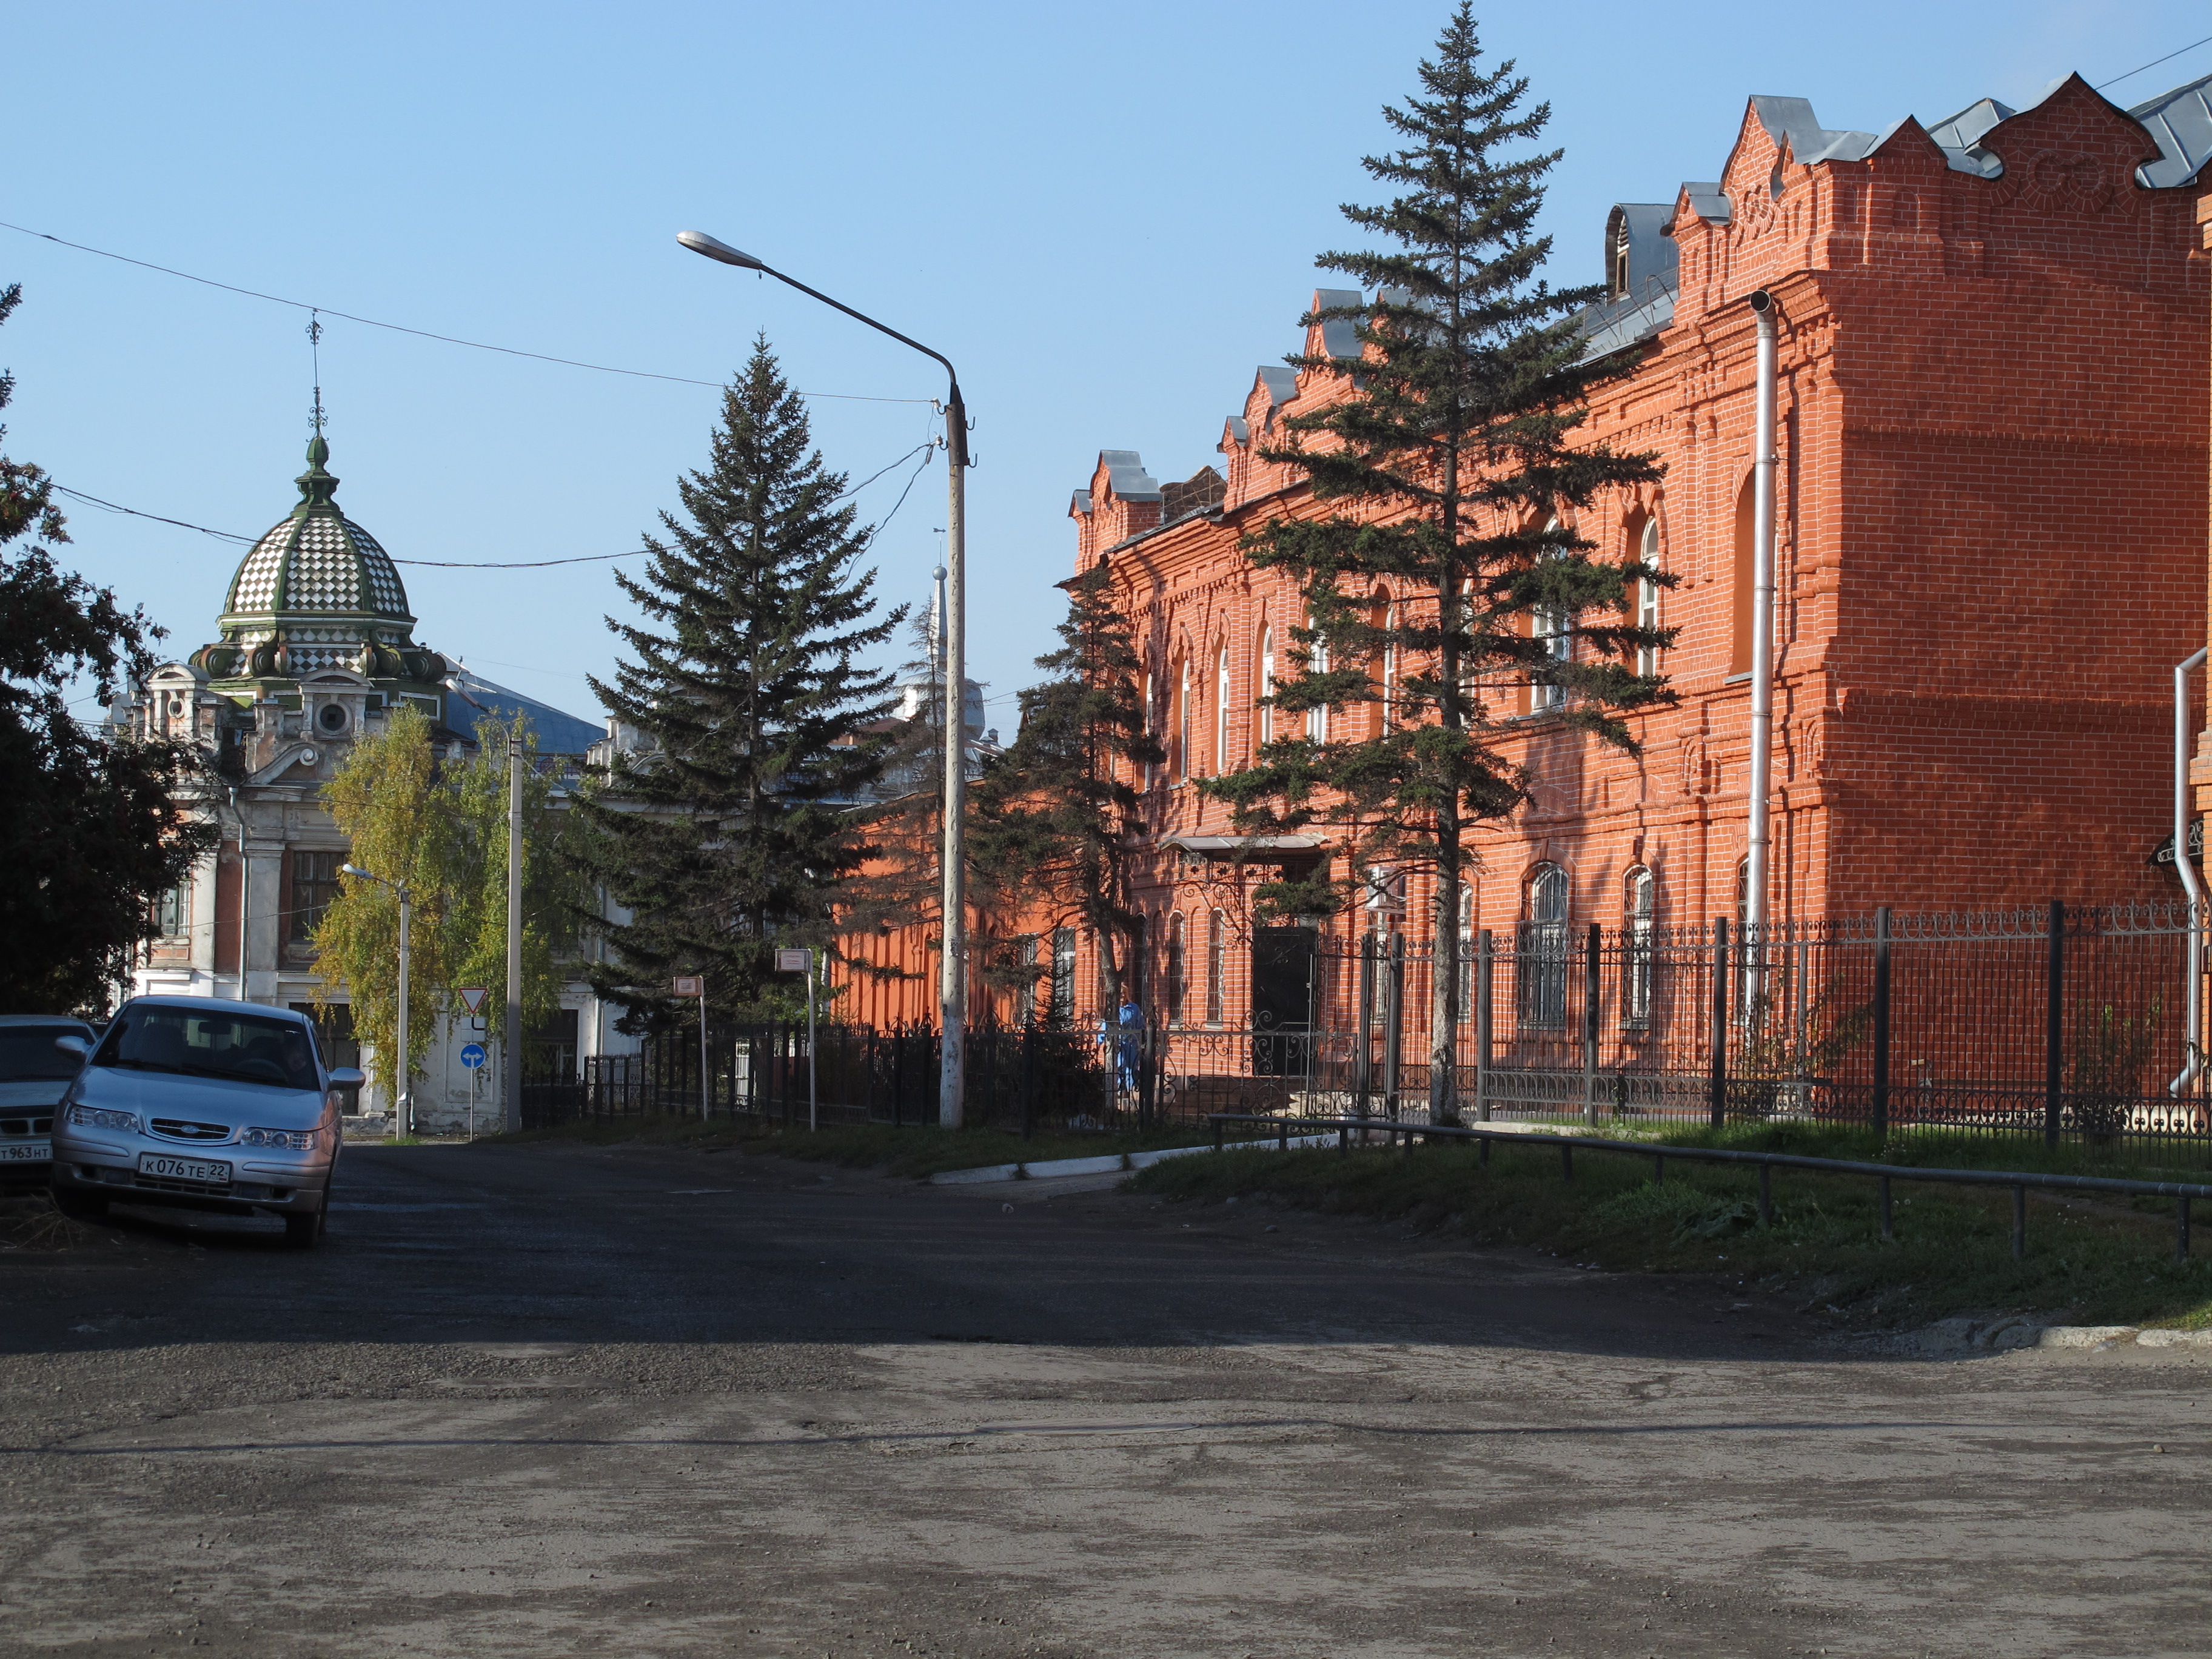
1204, 0, 1672, 1122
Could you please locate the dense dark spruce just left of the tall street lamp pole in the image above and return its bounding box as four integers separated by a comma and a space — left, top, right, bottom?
580, 336, 905, 1028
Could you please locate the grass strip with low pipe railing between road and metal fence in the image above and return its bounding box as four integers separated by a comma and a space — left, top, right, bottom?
1128, 1124, 2212, 1329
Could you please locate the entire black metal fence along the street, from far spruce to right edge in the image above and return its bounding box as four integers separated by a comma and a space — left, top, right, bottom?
522, 905, 2212, 1159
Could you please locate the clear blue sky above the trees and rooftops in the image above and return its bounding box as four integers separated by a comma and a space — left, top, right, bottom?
13, 0, 2212, 728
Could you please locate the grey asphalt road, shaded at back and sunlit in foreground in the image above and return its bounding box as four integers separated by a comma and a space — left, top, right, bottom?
0, 1146, 2212, 1659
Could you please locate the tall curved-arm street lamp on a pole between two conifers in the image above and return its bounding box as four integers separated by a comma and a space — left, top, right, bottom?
677, 230, 969, 1128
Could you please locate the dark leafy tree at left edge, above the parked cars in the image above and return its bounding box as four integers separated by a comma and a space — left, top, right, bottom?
0, 286, 217, 1013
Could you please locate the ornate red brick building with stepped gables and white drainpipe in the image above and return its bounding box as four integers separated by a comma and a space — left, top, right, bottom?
1026, 78, 2212, 1027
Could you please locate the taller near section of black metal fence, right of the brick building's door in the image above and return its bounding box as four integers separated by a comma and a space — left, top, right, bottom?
1282, 905, 2212, 1148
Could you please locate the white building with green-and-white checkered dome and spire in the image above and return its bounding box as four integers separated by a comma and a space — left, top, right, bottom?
115, 434, 637, 1133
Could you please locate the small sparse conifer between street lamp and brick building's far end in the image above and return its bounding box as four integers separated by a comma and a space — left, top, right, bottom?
971, 562, 1165, 1000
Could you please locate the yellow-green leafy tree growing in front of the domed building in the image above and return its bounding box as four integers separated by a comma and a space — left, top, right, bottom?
314, 708, 588, 1099
